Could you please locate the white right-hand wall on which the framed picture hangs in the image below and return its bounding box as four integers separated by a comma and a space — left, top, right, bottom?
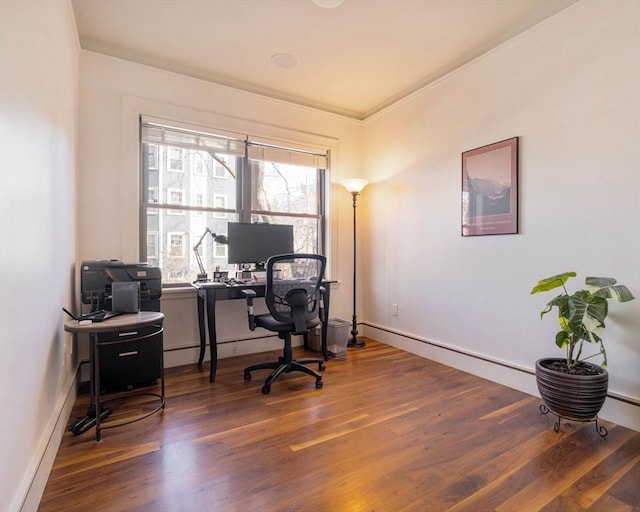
359, 1, 640, 429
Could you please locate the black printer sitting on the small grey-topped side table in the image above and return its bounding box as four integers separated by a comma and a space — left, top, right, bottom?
80, 260, 162, 311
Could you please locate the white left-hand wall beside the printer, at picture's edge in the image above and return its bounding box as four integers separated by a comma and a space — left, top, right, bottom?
0, 0, 79, 512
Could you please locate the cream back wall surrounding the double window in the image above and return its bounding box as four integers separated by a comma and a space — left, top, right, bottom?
78, 51, 362, 366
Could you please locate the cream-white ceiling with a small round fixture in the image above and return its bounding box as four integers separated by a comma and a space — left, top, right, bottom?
72, 0, 576, 119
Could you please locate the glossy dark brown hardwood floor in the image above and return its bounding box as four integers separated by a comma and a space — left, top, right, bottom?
39, 341, 640, 512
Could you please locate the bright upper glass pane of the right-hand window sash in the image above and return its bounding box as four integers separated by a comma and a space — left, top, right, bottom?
251, 160, 319, 215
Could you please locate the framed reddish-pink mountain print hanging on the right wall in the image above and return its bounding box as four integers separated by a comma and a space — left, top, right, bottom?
461, 137, 519, 236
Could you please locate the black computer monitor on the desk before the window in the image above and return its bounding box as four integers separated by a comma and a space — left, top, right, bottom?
227, 222, 293, 270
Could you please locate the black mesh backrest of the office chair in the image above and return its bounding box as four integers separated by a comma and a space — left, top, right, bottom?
265, 253, 327, 334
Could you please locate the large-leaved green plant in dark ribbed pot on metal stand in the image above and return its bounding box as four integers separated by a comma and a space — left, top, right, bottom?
531, 272, 635, 436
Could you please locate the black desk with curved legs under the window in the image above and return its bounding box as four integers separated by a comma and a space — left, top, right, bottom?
192, 281, 331, 382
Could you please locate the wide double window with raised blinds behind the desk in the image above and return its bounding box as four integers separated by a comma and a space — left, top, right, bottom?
140, 118, 327, 285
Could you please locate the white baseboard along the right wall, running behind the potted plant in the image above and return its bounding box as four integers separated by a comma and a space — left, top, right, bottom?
363, 323, 640, 431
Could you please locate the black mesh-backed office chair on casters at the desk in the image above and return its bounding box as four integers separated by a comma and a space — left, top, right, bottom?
243, 253, 327, 395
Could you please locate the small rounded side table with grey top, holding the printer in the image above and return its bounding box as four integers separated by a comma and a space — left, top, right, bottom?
64, 311, 165, 442
